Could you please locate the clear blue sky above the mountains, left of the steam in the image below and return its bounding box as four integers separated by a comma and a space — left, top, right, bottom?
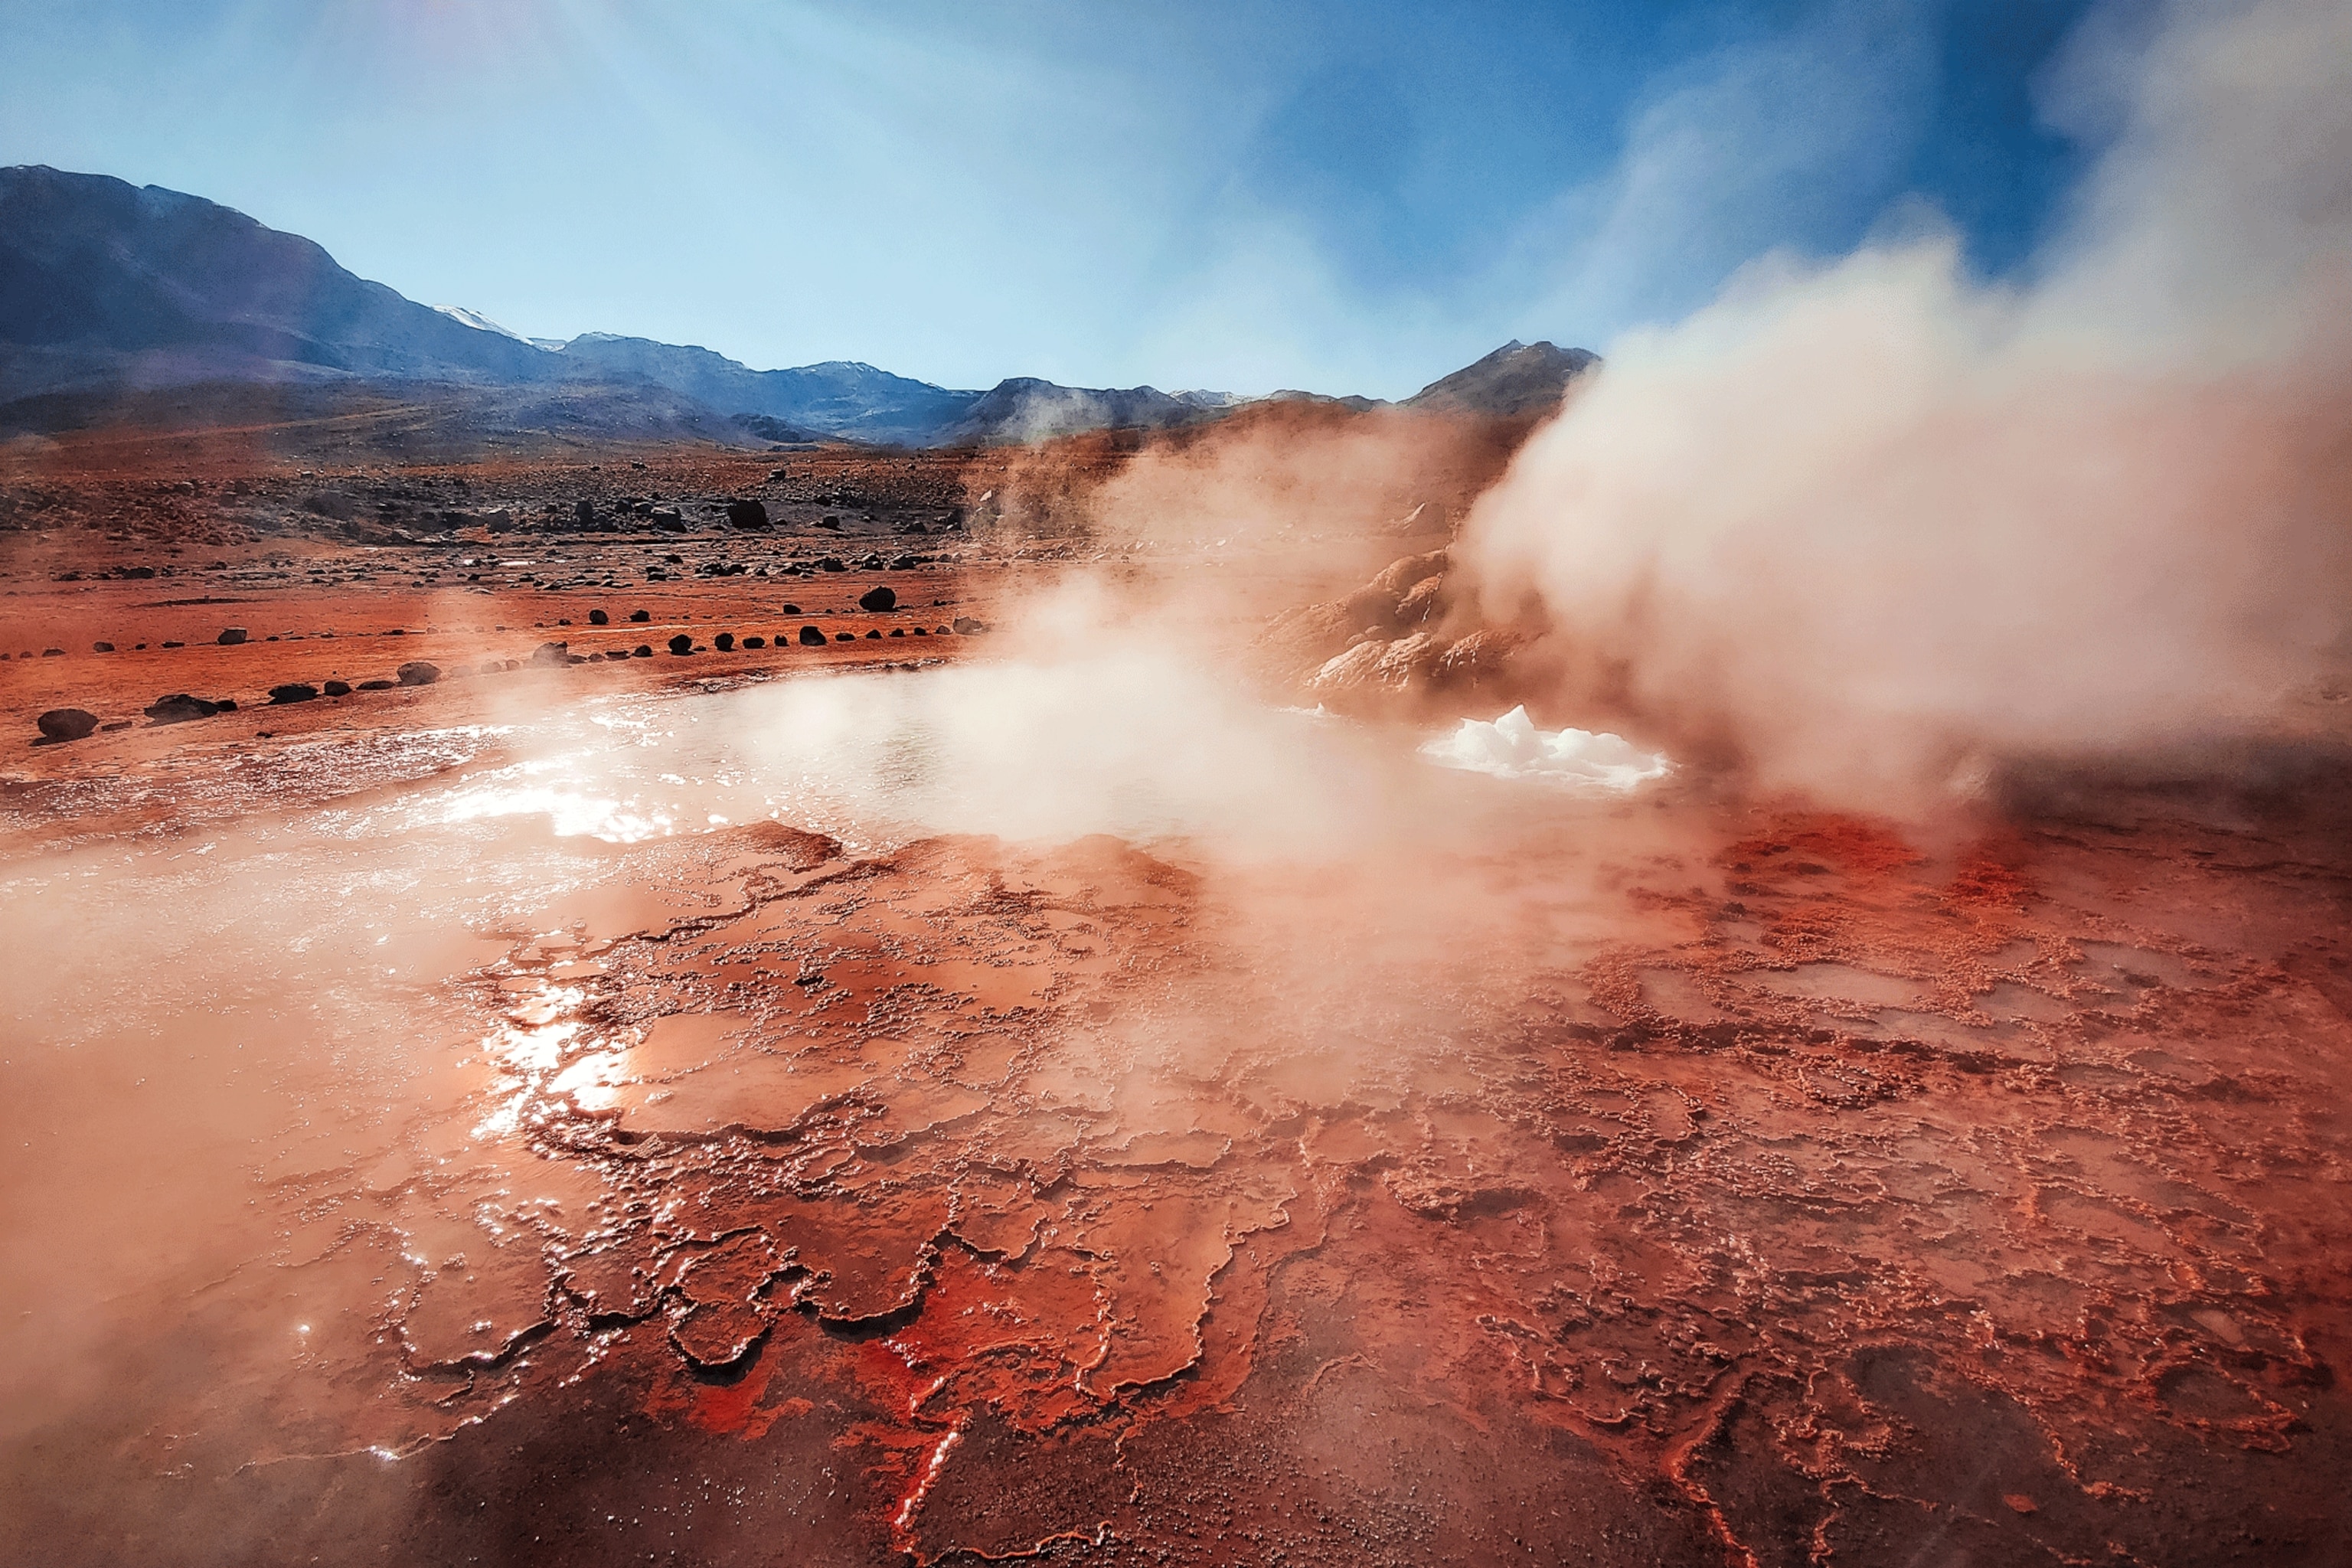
0, 0, 2091, 395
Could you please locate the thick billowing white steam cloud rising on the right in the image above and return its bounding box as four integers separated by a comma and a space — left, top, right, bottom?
1463, 0, 2352, 806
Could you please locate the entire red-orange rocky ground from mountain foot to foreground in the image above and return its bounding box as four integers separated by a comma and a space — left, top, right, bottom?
0, 390, 2352, 1568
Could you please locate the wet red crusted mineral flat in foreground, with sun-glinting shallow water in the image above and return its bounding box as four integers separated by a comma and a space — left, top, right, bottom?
0, 672, 2352, 1566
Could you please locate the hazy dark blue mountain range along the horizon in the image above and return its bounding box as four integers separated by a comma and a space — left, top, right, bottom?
0, 165, 1597, 446
